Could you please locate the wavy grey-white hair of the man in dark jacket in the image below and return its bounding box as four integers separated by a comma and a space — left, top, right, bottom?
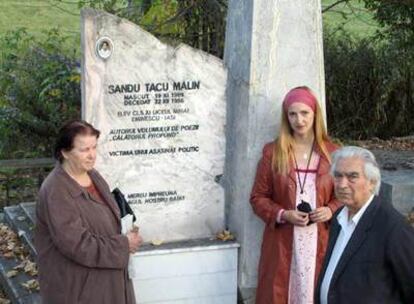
331, 146, 381, 195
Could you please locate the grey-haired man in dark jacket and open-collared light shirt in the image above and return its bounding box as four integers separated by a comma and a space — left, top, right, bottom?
315, 147, 414, 304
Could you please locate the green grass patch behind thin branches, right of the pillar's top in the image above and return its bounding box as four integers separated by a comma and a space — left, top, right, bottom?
322, 0, 379, 39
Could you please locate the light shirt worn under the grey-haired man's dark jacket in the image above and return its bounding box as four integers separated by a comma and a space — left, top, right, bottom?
320, 195, 374, 304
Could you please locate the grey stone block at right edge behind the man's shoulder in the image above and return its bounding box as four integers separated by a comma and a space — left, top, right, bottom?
380, 170, 414, 215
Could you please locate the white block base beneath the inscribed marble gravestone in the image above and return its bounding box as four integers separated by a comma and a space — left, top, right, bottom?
131, 239, 239, 304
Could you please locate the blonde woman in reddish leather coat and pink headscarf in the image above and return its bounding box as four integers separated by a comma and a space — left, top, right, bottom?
250, 87, 339, 304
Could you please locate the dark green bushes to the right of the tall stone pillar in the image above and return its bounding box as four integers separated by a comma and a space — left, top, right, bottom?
324, 33, 414, 139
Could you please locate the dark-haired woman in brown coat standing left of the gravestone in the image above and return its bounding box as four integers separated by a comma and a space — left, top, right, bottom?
35, 120, 142, 304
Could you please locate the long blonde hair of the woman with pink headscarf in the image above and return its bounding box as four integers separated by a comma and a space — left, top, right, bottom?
272, 86, 331, 174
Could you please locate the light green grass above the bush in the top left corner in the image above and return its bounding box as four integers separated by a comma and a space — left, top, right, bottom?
0, 0, 80, 49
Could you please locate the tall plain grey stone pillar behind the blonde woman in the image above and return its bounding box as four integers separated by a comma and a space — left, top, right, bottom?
224, 0, 325, 289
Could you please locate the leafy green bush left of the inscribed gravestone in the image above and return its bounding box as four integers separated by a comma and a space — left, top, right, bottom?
0, 29, 81, 158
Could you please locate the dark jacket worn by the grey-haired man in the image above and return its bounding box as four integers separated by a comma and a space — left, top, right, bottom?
315, 196, 414, 304
